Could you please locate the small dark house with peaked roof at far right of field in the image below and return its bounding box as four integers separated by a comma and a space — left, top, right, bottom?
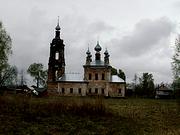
155, 84, 173, 98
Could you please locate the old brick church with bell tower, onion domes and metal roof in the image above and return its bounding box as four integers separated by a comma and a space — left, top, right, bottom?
47, 22, 125, 97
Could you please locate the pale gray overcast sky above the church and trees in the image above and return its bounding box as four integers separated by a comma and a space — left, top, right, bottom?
0, 0, 180, 83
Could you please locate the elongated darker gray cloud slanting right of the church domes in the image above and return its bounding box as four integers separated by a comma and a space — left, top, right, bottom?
110, 17, 174, 57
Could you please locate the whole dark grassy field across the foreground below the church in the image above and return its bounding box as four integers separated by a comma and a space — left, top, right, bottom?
0, 96, 180, 135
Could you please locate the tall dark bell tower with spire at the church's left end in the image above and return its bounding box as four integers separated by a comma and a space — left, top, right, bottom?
48, 17, 65, 82
